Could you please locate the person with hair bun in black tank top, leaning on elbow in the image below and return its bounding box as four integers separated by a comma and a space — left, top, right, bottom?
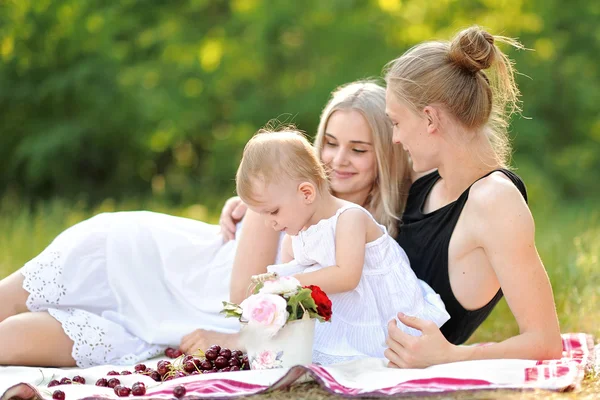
386, 27, 562, 368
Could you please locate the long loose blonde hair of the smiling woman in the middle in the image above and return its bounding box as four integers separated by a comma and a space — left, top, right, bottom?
314, 81, 410, 236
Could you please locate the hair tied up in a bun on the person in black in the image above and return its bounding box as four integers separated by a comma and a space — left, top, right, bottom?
385, 26, 523, 167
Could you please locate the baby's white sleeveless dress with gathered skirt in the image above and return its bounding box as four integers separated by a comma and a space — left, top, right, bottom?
268, 205, 450, 365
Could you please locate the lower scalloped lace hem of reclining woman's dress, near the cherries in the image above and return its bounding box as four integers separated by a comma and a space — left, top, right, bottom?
48, 308, 165, 368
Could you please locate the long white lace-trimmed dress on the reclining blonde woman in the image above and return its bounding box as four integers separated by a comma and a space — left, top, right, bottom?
21, 211, 278, 367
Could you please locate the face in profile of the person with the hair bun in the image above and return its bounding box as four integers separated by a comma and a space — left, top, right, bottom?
385, 89, 436, 172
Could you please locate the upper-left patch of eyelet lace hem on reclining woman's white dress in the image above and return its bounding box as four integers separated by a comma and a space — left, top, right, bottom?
21, 251, 67, 311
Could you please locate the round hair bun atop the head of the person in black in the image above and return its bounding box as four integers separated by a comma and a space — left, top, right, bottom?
448, 26, 496, 72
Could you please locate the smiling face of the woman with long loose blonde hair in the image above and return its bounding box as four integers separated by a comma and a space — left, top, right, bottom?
321, 110, 377, 205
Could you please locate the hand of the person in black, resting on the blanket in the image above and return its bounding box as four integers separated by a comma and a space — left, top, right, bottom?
384, 313, 460, 368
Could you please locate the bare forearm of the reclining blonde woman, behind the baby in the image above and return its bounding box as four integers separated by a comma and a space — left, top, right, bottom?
229, 210, 279, 304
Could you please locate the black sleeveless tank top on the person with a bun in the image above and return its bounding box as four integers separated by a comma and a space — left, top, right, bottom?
396, 169, 527, 344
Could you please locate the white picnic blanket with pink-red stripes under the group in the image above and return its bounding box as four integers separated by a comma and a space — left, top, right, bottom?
0, 333, 600, 400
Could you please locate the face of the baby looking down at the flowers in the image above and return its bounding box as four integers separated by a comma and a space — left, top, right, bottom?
248, 181, 310, 236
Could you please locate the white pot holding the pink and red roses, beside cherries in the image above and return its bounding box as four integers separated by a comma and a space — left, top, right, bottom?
241, 318, 315, 369
